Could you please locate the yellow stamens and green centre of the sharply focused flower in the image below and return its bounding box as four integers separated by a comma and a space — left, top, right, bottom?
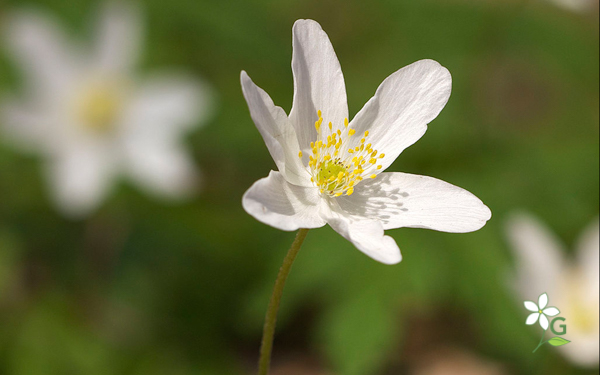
298, 111, 385, 197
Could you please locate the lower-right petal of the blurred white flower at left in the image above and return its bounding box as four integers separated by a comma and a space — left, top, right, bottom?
126, 138, 200, 199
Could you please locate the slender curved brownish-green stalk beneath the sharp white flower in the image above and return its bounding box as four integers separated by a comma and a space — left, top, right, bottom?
258, 228, 308, 375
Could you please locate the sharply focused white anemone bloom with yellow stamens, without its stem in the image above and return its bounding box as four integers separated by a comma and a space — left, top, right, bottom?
241, 20, 491, 264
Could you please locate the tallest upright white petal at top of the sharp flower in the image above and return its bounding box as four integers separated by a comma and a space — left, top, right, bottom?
290, 20, 348, 150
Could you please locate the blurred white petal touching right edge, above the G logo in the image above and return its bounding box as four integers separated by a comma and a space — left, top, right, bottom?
577, 219, 600, 301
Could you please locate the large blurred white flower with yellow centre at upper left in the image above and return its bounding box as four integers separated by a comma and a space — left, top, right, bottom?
0, 3, 208, 215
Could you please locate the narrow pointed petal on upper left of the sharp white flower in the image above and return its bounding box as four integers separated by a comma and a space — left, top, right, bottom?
240, 71, 313, 187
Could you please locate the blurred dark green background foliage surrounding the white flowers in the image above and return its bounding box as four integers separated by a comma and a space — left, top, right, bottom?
0, 0, 599, 375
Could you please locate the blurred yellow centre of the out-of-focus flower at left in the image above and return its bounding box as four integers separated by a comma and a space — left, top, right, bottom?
75, 82, 123, 133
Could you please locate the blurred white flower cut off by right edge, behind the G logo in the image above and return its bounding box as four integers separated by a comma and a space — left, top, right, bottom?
507, 213, 600, 367
